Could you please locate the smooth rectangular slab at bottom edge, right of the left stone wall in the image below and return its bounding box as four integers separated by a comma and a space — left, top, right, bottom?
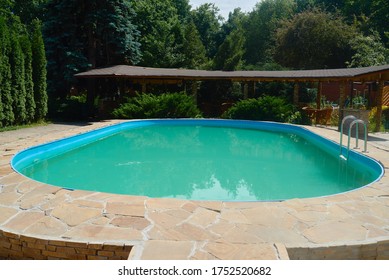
140, 240, 195, 260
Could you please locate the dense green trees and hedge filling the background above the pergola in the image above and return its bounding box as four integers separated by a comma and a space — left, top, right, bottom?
0, 0, 389, 126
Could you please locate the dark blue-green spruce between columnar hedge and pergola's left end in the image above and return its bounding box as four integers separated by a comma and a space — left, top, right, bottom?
43, 0, 140, 97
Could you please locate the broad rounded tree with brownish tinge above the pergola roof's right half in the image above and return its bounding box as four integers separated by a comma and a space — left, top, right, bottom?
275, 9, 356, 69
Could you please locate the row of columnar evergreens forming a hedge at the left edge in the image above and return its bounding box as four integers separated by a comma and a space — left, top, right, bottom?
0, 14, 47, 127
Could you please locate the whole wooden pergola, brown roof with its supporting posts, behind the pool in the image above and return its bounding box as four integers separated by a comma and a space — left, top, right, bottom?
75, 65, 389, 130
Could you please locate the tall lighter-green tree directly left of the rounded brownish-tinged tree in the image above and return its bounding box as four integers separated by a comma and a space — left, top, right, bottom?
244, 0, 296, 65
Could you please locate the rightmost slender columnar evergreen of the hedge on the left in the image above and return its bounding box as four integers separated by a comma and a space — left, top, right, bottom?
31, 20, 48, 121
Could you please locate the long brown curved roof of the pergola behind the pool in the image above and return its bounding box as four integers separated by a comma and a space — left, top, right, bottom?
75, 65, 389, 82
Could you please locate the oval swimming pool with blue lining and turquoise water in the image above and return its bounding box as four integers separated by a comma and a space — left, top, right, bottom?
12, 120, 382, 201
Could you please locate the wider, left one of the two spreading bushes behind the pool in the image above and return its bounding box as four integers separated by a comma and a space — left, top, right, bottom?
112, 93, 201, 119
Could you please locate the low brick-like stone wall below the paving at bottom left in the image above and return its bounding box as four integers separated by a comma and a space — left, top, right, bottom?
0, 230, 133, 260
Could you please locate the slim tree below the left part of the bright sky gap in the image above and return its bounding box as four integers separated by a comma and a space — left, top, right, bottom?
192, 3, 223, 58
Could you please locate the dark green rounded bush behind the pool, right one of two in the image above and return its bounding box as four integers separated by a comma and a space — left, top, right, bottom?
223, 96, 301, 123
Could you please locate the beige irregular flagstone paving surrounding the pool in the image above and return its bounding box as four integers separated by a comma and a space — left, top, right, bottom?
0, 120, 389, 260
